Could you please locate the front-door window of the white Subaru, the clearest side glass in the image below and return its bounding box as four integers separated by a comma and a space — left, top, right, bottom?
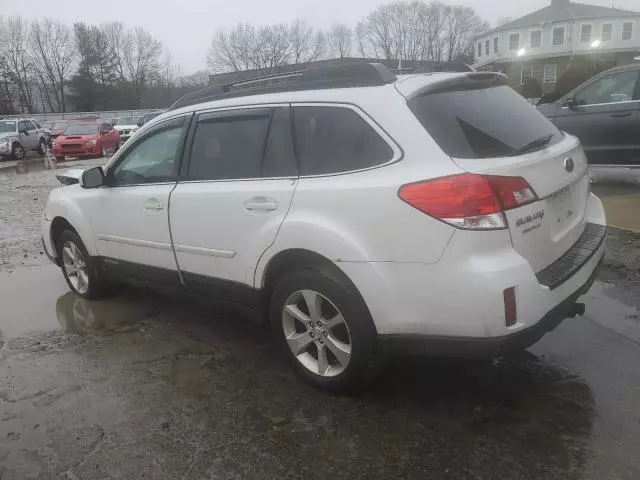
109, 118, 184, 186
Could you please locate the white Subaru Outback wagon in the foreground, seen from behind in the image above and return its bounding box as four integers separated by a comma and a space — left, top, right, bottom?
43, 64, 606, 390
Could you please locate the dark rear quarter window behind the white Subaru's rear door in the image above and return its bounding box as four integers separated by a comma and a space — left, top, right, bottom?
294, 106, 393, 175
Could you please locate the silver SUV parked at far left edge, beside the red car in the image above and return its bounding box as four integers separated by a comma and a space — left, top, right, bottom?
0, 118, 47, 160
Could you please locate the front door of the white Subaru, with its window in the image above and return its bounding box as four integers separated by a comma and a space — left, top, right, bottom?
82, 117, 187, 284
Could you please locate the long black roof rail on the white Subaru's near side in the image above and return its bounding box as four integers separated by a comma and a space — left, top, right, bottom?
169, 63, 396, 110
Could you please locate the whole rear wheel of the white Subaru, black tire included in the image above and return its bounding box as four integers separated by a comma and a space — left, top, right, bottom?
269, 266, 378, 393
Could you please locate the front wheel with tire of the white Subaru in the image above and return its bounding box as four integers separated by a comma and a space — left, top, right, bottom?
56, 230, 108, 300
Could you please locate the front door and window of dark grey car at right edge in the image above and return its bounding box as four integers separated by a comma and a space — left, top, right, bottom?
555, 70, 640, 165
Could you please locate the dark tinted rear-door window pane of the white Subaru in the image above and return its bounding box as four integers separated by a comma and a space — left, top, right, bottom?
187, 108, 271, 180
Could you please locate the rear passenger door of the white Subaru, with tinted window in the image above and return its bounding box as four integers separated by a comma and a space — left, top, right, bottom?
170, 106, 298, 303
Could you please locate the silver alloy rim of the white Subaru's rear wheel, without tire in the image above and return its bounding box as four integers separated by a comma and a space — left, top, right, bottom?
282, 290, 351, 377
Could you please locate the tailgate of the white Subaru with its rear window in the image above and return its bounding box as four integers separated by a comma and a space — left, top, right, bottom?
409, 80, 589, 272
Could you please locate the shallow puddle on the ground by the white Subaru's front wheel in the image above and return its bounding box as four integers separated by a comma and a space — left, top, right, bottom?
0, 265, 157, 339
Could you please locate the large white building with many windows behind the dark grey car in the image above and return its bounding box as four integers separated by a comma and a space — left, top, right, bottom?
474, 0, 640, 92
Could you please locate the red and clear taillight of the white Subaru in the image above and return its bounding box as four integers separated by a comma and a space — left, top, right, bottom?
398, 173, 538, 230
